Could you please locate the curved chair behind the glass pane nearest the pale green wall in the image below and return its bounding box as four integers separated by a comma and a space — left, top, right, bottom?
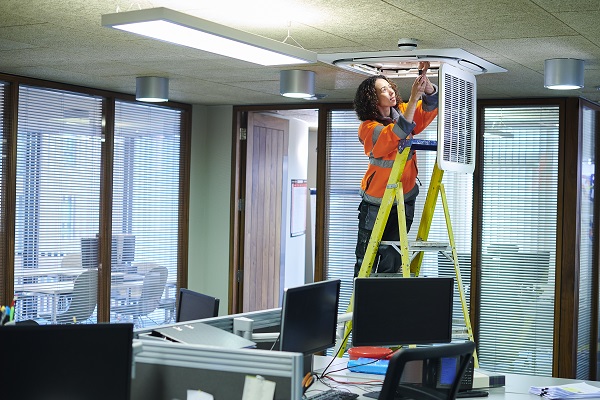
112, 264, 169, 327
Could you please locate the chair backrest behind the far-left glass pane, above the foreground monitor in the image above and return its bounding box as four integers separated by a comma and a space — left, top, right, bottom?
57, 269, 98, 323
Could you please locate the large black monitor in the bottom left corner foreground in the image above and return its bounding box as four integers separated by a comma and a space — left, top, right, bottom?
0, 324, 133, 400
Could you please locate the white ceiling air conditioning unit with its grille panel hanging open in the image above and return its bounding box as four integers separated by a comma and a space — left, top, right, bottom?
318, 47, 506, 173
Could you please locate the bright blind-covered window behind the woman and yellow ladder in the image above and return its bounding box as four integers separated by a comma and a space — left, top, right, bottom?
325, 110, 473, 346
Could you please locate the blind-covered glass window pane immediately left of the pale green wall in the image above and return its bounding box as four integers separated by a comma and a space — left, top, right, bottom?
111, 101, 181, 326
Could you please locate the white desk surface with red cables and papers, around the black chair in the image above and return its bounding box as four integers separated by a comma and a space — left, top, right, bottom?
306, 356, 600, 400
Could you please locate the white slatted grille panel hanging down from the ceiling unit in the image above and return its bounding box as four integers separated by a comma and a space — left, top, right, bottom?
438, 63, 477, 173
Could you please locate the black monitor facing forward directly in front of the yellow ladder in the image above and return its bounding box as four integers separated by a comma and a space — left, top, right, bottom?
352, 278, 454, 346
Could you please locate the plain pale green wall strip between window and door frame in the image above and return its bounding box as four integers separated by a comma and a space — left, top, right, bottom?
188, 105, 233, 315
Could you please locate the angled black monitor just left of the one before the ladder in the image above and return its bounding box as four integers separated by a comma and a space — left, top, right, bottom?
279, 279, 341, 356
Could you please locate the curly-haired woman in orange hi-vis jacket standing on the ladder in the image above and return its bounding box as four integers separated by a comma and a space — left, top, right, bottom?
354, 62, 438, 276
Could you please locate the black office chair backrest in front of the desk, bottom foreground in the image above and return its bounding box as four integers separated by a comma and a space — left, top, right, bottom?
379, 341, 475, 400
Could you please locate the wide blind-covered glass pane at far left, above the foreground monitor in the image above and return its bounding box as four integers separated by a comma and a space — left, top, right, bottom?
14, 85, 102, 323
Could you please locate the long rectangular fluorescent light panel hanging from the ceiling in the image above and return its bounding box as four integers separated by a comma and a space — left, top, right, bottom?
102, 7, 317, 65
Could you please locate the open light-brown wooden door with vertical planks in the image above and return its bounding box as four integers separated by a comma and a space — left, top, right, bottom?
242, 112, 289, 312
